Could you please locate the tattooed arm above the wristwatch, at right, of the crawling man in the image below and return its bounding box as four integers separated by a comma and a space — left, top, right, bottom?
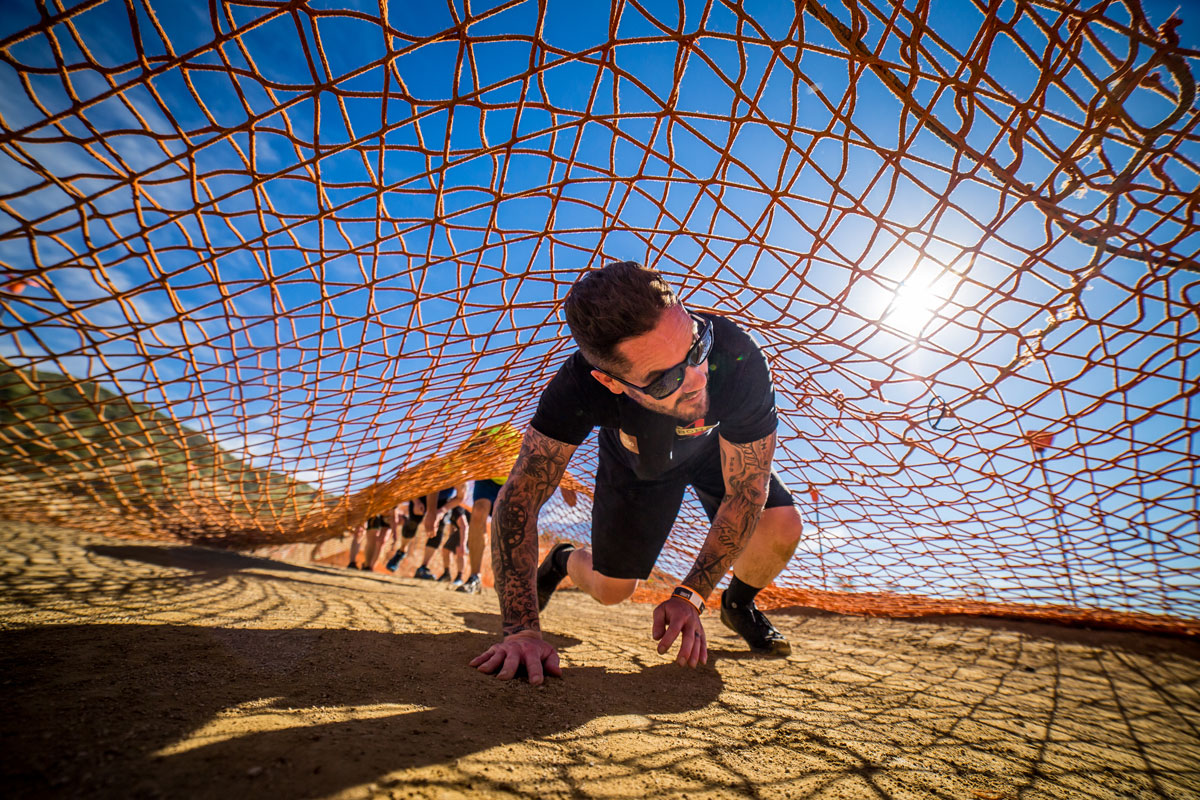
684, 433, 775, 597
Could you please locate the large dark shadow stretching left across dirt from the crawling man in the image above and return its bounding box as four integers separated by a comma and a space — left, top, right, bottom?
0, 620, 721, 798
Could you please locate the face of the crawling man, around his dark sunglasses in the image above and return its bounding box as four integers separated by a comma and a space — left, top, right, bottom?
592, 305, 708, 422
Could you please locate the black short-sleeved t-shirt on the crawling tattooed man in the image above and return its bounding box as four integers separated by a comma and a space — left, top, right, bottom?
532, 314, 779, 479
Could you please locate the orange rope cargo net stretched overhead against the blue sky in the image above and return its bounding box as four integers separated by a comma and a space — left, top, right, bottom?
0, 0, 1200, 633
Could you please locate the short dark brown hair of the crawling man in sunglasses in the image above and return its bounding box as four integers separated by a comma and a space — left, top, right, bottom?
566, 261, 679, 369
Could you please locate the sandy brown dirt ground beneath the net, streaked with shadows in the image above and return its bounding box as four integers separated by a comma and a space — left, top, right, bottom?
0, 523, 1200, 800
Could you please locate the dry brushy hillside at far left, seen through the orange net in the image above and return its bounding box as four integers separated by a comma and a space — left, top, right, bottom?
0, 362, 331, 543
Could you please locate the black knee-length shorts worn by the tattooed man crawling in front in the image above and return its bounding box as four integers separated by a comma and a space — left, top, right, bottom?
592, 428, 796, 579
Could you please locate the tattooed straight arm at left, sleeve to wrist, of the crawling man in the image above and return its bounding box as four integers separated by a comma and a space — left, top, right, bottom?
492, 426, 575, 636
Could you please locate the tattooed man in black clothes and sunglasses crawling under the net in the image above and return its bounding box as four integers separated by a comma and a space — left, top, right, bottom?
470, 261, 803, 684
